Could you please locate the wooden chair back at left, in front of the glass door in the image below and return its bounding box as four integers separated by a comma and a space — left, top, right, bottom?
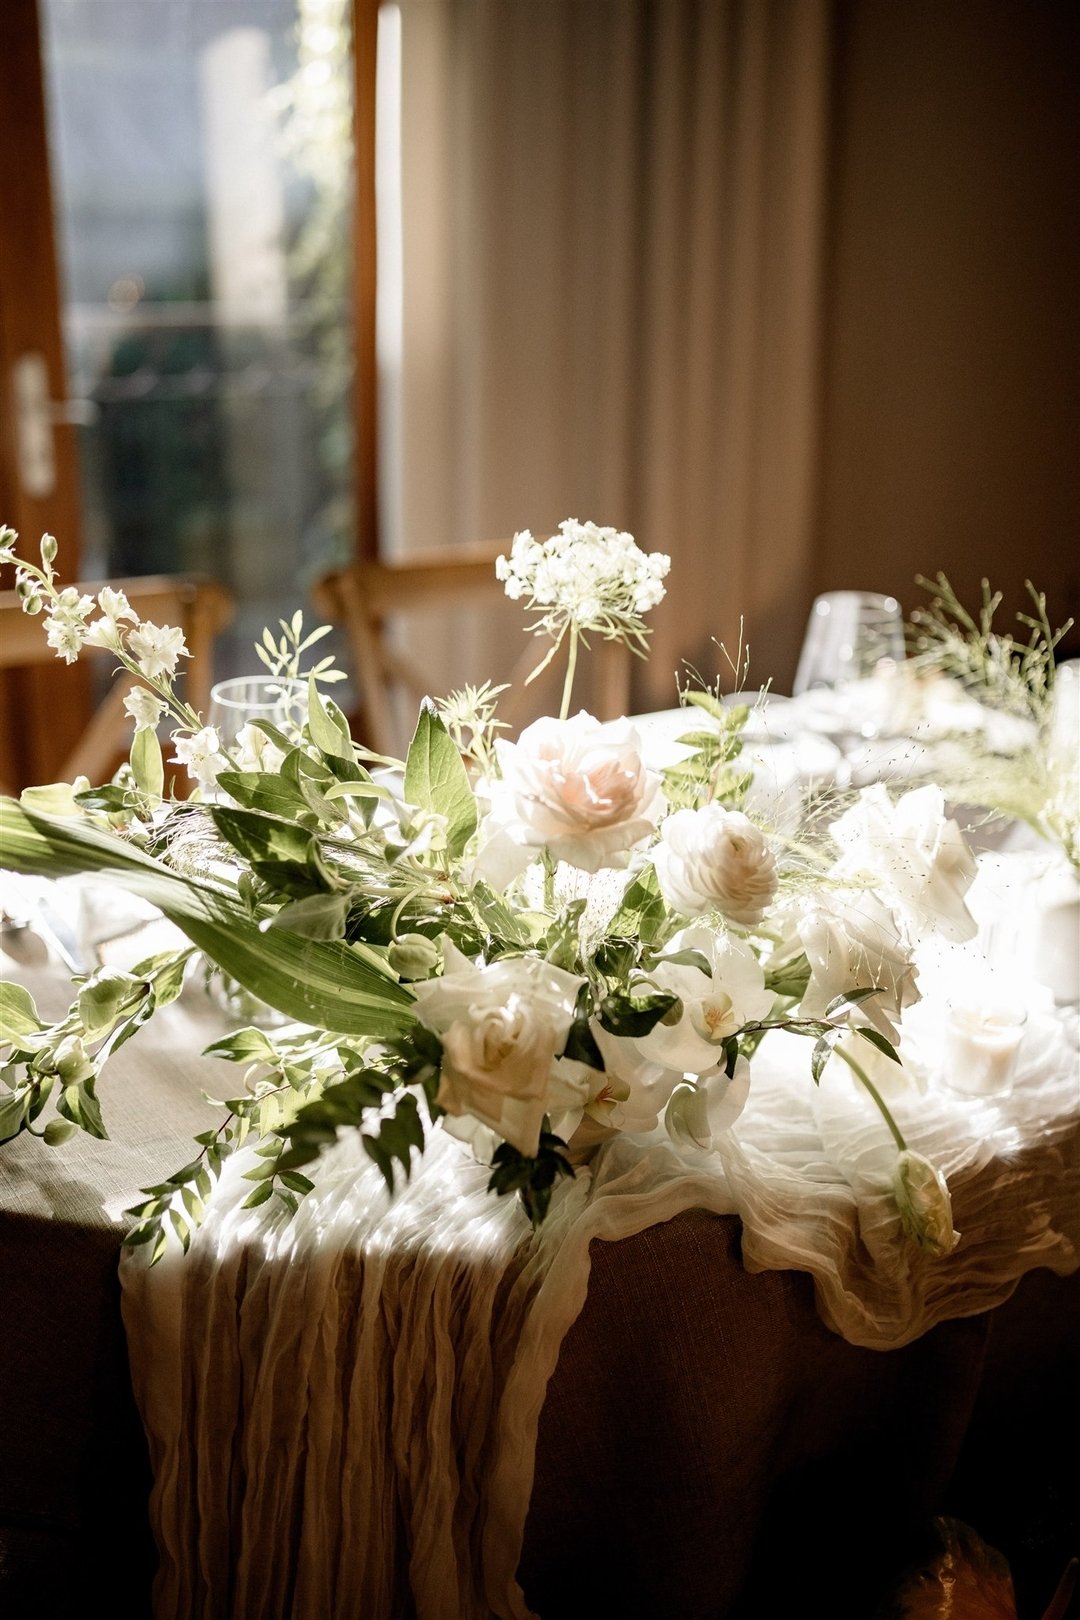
0, 575, 233, 794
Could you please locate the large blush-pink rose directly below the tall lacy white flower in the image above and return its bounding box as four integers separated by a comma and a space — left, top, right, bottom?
476, 713, 664, 888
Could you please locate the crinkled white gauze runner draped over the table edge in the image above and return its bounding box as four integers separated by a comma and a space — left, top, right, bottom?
121, 1014, 1080, 1620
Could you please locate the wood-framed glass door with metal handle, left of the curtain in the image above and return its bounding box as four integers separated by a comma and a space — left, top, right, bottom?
0, 0, 379, 789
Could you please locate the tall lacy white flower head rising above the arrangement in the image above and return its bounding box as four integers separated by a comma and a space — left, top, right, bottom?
495, 518, 670, 637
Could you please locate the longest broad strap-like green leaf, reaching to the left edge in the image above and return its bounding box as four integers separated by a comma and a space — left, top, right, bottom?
0, 799, 415, 1037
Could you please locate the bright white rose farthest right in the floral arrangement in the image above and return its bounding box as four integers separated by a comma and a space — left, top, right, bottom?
832, 782, 976, 941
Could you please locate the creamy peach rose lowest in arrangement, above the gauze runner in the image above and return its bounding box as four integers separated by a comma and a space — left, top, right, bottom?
413, 941, 581, 1155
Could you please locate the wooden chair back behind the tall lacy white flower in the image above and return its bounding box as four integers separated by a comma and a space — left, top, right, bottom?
313, 541, 631, 755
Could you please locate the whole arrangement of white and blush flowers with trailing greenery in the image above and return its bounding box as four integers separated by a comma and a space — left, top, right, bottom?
0, 522, 975, 1259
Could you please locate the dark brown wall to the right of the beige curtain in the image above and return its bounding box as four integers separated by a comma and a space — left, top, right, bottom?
814, 0, 1080, 651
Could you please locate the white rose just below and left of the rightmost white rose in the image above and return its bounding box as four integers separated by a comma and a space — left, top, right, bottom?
795, 891, 918, 1040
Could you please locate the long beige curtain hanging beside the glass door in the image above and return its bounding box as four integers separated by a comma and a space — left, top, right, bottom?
387, 0, 829, 710
